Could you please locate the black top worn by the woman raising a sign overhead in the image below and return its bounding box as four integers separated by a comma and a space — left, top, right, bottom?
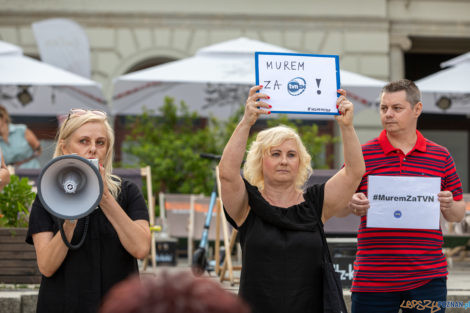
225, 181, 325, 313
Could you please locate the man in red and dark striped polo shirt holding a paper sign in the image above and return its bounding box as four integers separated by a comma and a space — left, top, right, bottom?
347, 79, 465, 313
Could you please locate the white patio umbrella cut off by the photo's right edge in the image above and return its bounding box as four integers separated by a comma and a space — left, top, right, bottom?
416, 52, 470, 115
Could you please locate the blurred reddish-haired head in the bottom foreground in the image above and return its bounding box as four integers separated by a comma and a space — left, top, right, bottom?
100, 271, 250, 313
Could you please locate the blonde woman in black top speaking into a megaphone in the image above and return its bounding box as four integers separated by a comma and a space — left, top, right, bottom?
26, 109, 150, 313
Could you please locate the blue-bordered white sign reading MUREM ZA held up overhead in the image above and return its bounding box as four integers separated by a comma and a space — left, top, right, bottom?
255, 52, 341, 115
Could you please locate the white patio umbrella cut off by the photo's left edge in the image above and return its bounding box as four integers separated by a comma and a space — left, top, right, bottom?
0, 41, 107, 115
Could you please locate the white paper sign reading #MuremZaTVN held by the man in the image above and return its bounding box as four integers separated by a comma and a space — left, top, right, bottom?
367, 176, 441, 229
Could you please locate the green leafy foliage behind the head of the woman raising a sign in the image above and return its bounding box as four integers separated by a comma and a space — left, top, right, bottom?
125, 97, 337, 201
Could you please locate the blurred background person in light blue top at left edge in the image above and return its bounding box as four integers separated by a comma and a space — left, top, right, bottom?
0, 105, 41, 168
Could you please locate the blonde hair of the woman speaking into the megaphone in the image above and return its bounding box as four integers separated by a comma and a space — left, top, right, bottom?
54, 111, 121, 198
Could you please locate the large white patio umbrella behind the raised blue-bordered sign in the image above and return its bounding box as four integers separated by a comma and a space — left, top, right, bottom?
112, 38, 385, 119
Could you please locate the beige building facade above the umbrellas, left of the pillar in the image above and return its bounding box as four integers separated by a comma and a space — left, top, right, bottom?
0, 0, 389, 96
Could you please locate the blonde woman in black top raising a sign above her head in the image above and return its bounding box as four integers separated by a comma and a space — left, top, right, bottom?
219, 86, 365, 313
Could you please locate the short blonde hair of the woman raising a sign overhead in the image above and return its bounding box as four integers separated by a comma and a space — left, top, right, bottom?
243, 125, 313, 190
